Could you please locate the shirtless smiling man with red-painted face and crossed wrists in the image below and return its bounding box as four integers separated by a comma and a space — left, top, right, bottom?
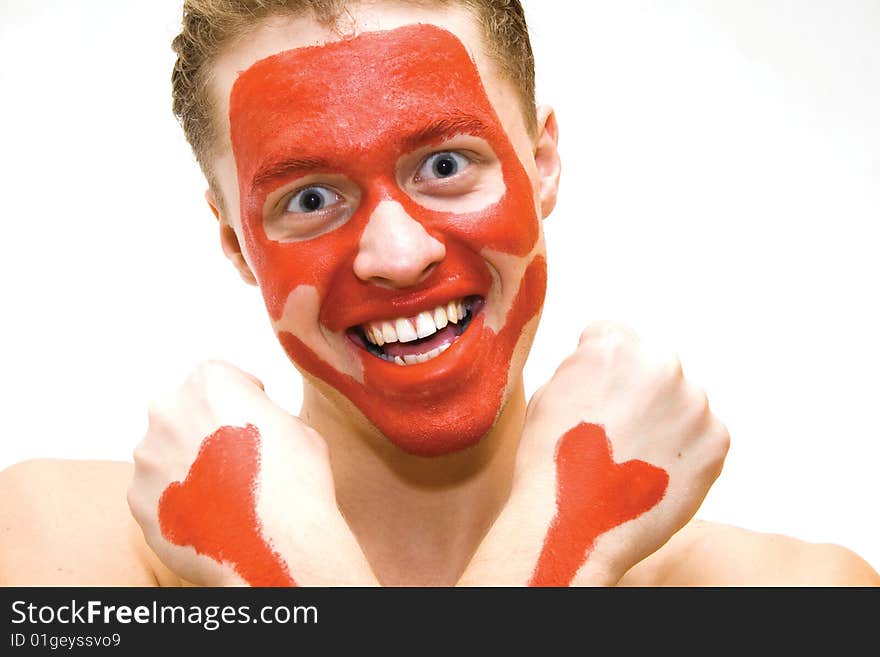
0, 0, 880, 585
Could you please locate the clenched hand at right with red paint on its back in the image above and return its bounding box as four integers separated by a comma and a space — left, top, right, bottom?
460, 322, 730, 586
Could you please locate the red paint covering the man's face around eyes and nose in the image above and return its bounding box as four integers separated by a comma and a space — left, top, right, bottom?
229, 25, 546, 455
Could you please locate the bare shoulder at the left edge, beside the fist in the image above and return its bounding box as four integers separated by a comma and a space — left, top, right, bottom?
0, 459, 178, 586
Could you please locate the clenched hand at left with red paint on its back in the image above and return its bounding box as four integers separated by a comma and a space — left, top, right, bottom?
128, 361, 376, 586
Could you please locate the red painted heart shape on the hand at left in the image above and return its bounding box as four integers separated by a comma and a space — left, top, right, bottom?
159, 425, 296, 586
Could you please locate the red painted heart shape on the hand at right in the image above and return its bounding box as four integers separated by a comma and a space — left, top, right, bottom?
529, 423, 669, 586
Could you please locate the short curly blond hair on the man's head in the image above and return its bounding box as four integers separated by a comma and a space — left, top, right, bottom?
171, 0, 537, 196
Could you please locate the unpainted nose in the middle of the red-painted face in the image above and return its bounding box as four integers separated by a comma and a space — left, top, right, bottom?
354, 201, 446, 288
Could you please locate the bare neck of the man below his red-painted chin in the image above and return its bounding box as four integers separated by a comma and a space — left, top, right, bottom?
300, 377, 526, 586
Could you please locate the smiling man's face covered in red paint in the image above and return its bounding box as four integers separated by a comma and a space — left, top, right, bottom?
210, 6, 546, 455
